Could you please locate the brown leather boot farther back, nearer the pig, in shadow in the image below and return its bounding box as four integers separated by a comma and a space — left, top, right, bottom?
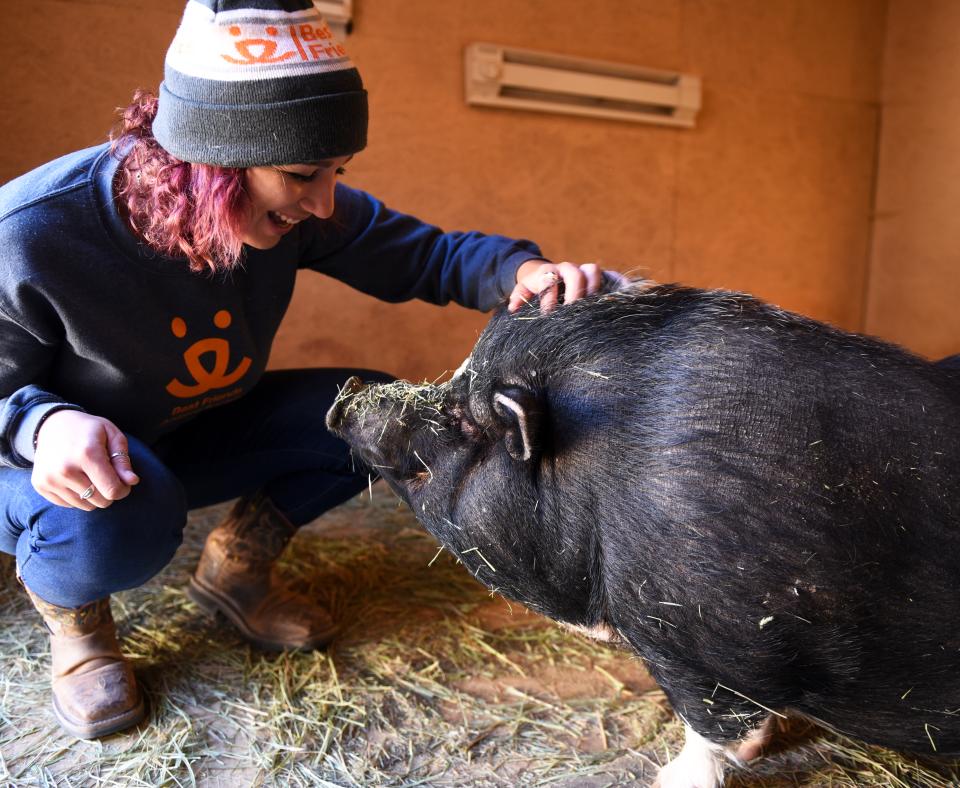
187, 493, 336, 651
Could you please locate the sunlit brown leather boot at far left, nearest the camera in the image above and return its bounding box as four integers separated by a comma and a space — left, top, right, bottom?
24, 586, 147, 739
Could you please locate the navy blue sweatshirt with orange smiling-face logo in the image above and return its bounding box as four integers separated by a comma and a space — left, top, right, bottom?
0, 145, 540, 468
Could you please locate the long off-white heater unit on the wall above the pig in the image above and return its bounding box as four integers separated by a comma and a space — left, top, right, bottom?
464, 43, 700, 126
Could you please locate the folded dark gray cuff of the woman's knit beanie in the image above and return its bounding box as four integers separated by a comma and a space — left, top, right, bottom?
153, 83, 367, 167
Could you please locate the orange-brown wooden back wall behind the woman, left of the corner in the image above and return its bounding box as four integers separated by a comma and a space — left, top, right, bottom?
0, 0, 900, 378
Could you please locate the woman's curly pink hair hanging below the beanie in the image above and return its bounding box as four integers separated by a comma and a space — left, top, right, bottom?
111, 90, 249, 273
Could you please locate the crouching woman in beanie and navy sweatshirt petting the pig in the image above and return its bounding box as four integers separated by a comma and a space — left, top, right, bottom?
0, 0, 616, 738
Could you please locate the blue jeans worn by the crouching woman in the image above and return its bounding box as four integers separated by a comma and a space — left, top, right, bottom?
0, 369, 393, 607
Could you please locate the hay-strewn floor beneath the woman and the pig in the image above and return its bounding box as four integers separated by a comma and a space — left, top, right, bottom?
0, 485, 958, 788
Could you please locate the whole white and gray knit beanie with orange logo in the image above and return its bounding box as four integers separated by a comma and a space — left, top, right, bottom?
153, 0, 367, 167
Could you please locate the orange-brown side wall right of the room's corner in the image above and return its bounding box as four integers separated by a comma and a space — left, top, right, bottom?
865, 0, 960, 358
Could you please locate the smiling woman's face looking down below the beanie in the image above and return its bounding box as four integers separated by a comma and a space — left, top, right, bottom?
240, 156, 353, 249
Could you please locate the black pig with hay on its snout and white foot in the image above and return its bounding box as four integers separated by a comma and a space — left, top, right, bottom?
327, 283, 960, 786
